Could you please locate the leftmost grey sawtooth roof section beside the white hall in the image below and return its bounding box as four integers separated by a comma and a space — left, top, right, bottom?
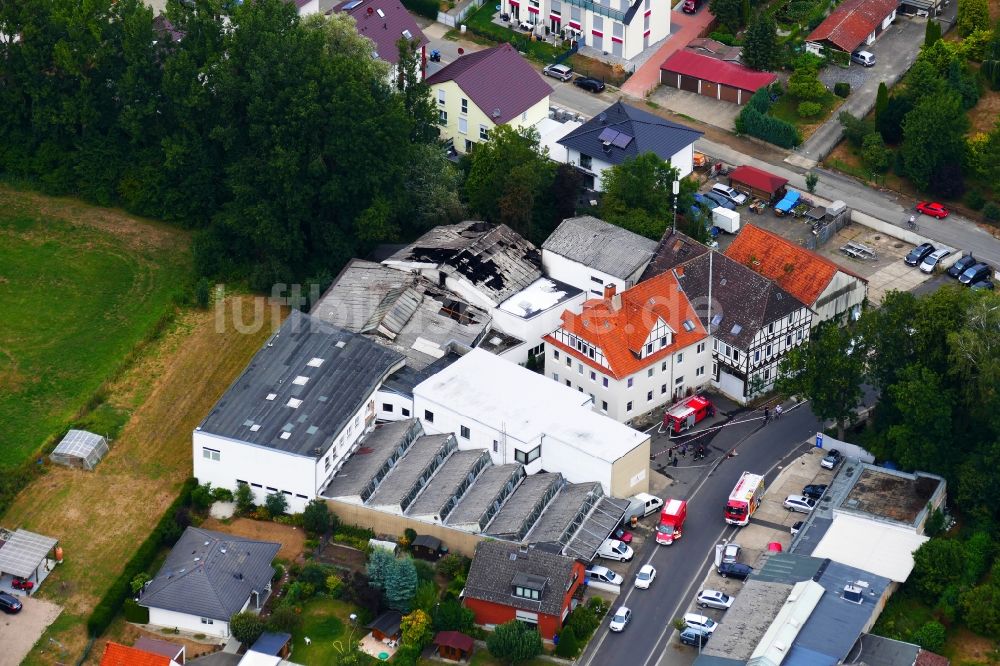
323, 419, 423, 499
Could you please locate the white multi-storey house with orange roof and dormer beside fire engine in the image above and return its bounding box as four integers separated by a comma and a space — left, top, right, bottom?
545, 271, 712, 422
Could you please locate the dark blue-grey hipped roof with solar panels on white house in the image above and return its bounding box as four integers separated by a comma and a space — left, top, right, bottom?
559, 102, 703, 169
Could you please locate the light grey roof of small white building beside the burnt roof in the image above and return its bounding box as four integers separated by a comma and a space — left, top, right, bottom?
542, 215, 657, 279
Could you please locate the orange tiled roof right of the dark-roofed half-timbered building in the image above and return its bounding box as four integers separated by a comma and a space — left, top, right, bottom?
725, 224, 863, 306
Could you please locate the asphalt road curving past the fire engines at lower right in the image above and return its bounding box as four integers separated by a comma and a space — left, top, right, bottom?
580, 405, 820, 666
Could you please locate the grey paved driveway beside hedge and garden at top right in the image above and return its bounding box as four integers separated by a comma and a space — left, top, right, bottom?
785, 11, 940, 169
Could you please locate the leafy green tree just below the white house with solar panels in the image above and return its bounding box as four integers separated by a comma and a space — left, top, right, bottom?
601, 153, 678, 239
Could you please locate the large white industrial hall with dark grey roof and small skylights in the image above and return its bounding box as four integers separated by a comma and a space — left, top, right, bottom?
192, 311, 404, 512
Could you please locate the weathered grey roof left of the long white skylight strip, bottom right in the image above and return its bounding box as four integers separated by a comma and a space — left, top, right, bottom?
702, 572, 792, 663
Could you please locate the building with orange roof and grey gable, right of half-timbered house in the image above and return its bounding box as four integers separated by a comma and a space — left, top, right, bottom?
726, 224, 868, 326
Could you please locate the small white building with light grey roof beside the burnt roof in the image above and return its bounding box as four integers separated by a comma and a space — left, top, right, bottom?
542, 215, 657, 298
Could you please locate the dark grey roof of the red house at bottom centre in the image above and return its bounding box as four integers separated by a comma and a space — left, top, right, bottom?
465, 541, 575, 617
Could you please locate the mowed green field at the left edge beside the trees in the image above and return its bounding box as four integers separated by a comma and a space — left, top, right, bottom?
0, 185, 189, 470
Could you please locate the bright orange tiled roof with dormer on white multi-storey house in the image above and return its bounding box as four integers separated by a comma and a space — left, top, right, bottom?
545, 271, 708, 379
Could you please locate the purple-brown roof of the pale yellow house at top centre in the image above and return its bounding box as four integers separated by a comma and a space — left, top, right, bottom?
427, 44, 552, 125
